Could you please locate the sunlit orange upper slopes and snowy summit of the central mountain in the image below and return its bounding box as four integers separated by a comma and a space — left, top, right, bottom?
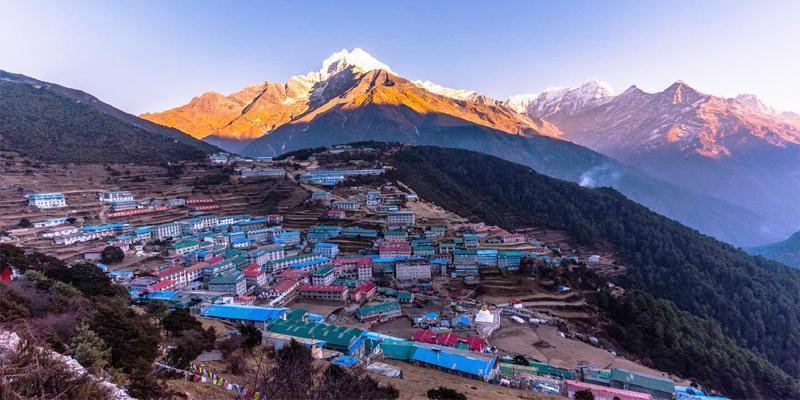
142, 49, 555, 146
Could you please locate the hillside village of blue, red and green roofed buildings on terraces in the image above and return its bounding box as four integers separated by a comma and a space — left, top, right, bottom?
0, 146, 722, 400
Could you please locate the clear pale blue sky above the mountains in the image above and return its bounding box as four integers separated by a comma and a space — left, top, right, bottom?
0, 0, 800, 114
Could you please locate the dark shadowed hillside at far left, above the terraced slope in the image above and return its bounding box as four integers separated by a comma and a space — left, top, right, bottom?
0, 71, 217, 163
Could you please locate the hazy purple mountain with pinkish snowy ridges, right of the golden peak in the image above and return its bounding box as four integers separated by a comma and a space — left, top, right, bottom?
508, 81, 800, 241
